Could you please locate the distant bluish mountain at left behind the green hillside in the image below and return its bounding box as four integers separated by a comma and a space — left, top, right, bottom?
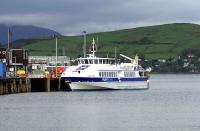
0, 24, 60, 44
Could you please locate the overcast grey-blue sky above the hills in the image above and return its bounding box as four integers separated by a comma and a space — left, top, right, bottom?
0, 0, 200, 35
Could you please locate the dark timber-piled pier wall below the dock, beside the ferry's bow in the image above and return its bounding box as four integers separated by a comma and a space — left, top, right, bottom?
0, 77, 70, 95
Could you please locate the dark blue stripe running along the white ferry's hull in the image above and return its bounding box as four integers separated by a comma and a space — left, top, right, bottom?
63, 77, 148, 82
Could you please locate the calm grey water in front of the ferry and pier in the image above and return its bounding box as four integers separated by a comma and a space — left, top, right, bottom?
0, 75, 200, 131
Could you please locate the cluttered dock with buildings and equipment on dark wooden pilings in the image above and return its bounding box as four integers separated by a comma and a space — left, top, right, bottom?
0, 48, 70, 95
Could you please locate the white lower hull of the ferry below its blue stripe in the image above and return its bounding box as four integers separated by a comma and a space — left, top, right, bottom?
69, 81, 149, 91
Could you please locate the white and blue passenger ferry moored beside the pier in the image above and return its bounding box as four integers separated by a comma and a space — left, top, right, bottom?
61, 39, 149, 91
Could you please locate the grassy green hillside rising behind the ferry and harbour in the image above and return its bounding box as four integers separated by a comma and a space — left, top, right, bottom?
16, 23, 200, 59
